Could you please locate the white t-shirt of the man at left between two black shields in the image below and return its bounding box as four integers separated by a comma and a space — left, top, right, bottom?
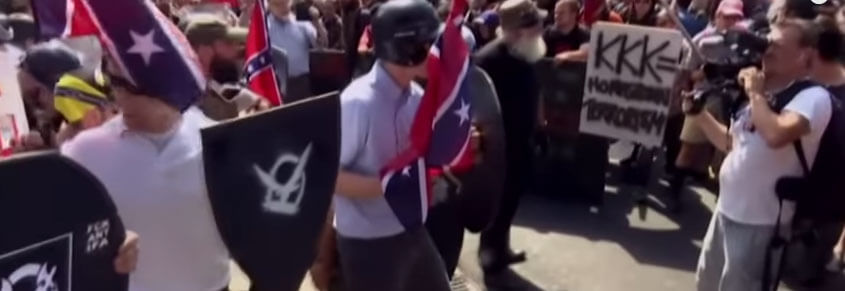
61, 114, 229, 291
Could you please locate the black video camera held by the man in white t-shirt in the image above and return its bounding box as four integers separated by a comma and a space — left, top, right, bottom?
690, 30, 769, 114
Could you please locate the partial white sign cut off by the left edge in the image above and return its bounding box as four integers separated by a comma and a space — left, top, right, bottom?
0, 51, 29, 155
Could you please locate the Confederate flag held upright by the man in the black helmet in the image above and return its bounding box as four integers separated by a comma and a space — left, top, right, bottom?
381, 0, 473, 229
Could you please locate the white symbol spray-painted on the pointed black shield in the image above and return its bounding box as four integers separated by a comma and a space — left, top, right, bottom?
256, 144, 312, 216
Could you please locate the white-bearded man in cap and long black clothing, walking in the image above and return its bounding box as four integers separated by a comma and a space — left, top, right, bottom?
476, 0, 546, 272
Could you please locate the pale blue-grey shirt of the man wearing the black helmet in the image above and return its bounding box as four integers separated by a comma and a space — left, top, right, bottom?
334, 62, 423, 238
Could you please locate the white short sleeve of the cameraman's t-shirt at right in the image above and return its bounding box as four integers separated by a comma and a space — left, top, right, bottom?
783, 86, 833, 132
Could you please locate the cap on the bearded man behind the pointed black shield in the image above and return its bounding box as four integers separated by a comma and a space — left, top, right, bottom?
183, 13, 248, 46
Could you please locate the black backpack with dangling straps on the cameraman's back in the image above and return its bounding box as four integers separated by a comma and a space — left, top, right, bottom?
763, 81, 845, 291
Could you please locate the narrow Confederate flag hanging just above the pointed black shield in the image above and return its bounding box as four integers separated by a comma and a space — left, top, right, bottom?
244, 1, 283, 106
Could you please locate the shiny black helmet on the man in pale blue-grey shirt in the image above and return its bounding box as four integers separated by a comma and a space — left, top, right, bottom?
372, 0, 440, 66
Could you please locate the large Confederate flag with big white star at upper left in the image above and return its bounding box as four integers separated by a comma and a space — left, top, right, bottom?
58, 0, 206, 110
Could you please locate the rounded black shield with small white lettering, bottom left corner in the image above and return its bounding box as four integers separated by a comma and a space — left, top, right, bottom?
0, 153, 128, 291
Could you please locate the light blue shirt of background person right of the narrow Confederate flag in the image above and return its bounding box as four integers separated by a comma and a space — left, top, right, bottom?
267, 14, 317, 77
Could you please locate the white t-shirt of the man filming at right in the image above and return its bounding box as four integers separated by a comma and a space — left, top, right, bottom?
717, 86, 832, 225
